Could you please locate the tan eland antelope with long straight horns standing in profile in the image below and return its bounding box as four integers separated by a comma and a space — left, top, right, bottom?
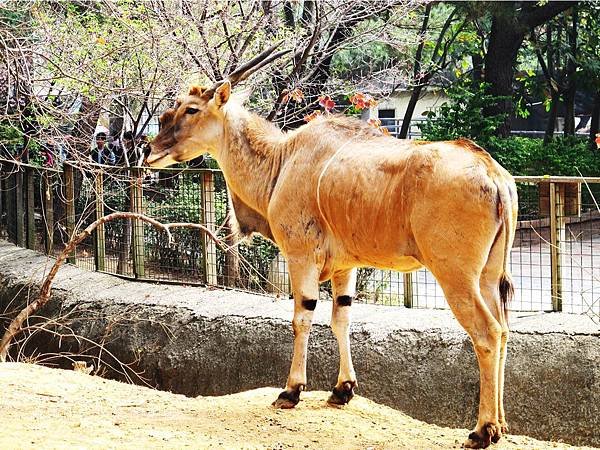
147, 44, 517, 448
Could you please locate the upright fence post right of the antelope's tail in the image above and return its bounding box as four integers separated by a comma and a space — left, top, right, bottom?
550, 183, 566, 311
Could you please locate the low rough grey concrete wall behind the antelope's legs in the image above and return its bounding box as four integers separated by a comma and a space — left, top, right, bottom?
0, 241, 600, 445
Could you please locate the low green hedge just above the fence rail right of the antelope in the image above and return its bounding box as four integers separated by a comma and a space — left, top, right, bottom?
486, 136, 600, 176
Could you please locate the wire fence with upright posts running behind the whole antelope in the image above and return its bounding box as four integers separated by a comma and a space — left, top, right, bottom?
0, 160, 600, 315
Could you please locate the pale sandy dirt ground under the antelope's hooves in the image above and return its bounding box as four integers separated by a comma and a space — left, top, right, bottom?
0, 363, 596, 450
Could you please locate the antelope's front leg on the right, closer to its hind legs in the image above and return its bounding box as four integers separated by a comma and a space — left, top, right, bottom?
327, 269, 358, 405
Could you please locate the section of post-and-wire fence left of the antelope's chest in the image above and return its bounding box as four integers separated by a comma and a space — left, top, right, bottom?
0, 160, 290, 295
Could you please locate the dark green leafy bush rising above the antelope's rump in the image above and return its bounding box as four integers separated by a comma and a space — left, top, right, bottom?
419, 78, 504, 141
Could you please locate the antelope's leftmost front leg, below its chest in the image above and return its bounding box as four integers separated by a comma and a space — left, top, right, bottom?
273, 258, 319, 409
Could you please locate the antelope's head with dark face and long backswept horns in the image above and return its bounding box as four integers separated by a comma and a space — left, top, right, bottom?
146, 43, 289, 167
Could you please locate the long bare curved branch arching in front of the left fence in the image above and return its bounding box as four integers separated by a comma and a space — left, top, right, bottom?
0, 212, 228, 362
